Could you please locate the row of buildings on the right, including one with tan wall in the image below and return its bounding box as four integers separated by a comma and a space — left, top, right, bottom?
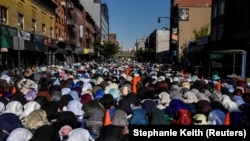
135, 0, 250, 78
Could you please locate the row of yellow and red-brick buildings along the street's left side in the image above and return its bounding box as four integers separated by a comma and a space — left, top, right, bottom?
0, 0, 118, 68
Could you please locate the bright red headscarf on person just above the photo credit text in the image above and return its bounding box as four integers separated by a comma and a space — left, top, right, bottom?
172, 109, 193, 125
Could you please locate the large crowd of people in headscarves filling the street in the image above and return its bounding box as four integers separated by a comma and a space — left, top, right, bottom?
0, 61, 250, 141
